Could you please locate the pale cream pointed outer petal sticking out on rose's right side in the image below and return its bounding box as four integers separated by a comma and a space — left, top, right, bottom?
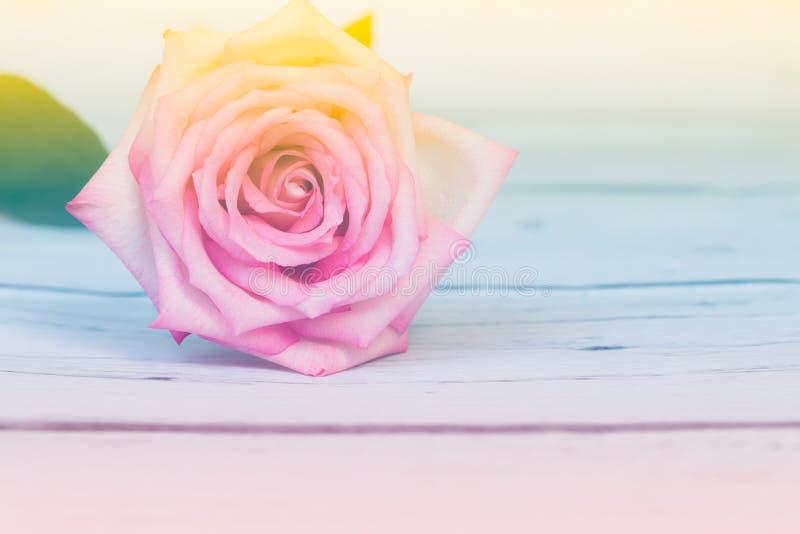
412, 113, 518, 236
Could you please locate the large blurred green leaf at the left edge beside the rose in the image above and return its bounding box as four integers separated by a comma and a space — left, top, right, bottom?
0, 75, 107, 225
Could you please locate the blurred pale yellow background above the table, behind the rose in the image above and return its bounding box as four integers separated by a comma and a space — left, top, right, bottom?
6, 0, 800, 145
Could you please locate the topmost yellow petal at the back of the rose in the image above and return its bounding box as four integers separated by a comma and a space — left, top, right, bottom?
222, 0, 403, 81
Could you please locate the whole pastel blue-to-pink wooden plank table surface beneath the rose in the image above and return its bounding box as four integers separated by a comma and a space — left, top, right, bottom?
0, 123, 800, 533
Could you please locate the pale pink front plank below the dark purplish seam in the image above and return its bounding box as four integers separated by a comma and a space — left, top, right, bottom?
0, 432, 800, 534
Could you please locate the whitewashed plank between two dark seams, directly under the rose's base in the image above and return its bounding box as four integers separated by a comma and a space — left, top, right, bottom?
0, 285, 800, 423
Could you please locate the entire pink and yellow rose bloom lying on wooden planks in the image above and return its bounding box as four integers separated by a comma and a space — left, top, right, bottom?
67, 0, 517, 376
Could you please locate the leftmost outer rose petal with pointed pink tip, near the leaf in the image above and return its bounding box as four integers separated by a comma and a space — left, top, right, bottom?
67, 69, 159, 306
